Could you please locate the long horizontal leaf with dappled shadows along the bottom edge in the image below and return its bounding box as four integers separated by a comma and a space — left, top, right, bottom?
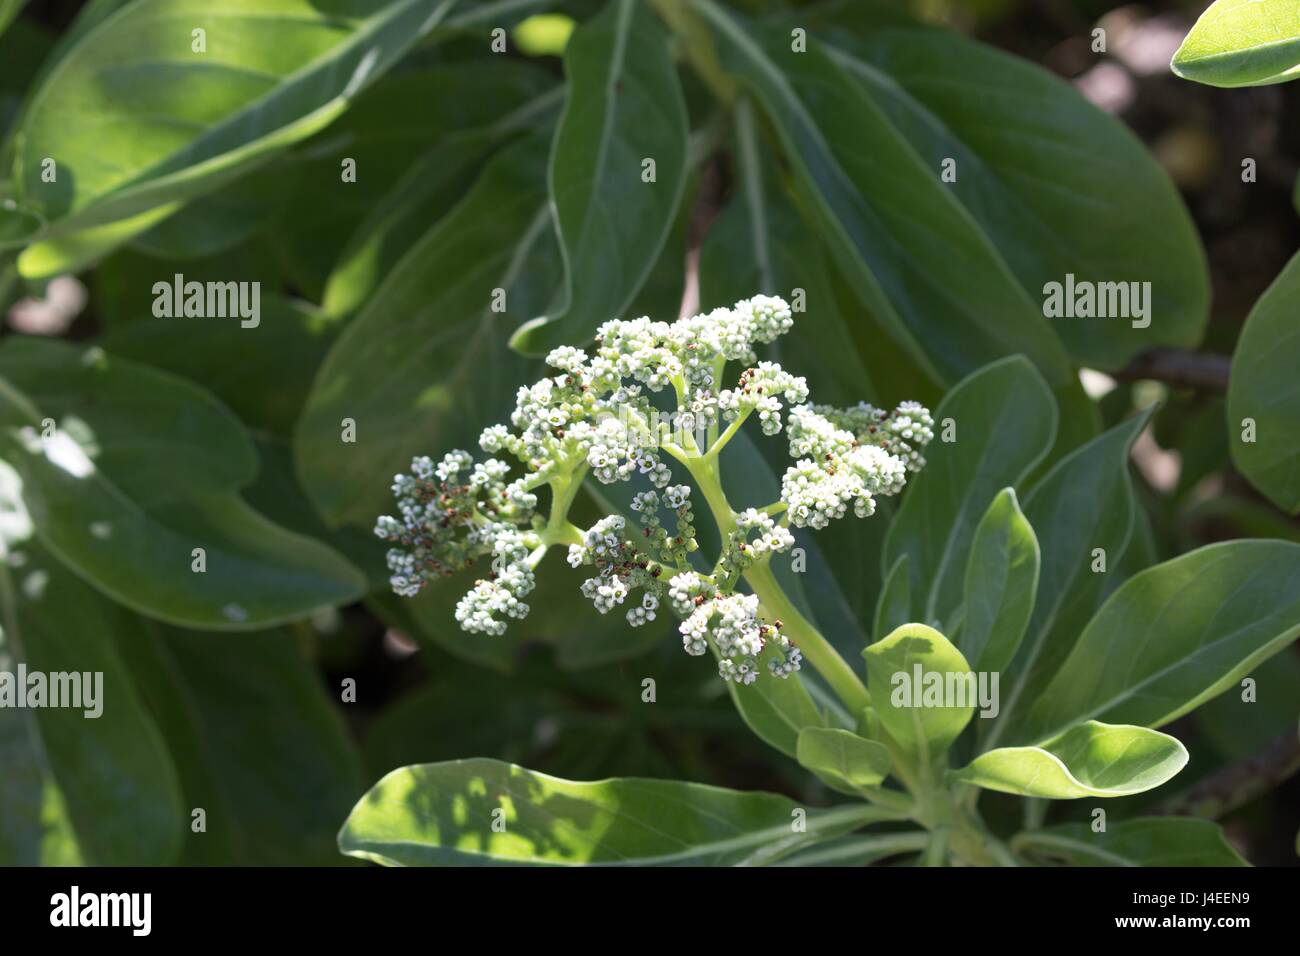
338, 760, 880, 866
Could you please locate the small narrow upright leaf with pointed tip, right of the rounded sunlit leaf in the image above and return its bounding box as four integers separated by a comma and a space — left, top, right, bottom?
958, 488, 1039, 671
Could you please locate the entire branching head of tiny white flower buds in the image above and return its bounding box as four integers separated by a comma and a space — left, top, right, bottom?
376, 295, 933, 684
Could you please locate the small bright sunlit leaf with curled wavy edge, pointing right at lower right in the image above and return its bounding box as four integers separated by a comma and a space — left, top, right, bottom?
949, 721, 1187, 800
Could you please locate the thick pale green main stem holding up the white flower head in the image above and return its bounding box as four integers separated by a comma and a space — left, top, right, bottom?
685, 458, 871, 714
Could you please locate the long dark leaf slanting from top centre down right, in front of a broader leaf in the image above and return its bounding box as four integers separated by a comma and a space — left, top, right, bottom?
696, 0, 1093, 436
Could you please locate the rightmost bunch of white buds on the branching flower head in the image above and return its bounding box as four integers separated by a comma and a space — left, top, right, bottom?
781, 402, 935, 528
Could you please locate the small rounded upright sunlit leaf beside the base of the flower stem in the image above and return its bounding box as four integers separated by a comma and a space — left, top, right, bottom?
862, 624, 976, 767
